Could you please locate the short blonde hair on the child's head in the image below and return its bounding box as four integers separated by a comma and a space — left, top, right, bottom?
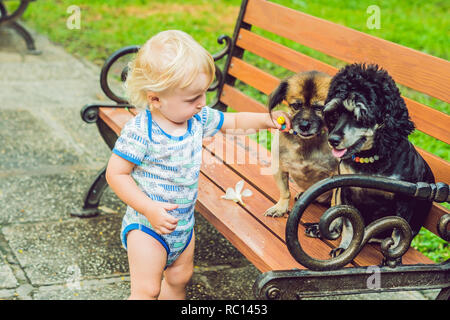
125, 30, 215, 108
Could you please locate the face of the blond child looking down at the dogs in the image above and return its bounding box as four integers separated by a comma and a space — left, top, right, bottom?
154, 73, 209, 123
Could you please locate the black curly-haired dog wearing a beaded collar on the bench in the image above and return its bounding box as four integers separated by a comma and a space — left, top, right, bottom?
324, 64, 434, 256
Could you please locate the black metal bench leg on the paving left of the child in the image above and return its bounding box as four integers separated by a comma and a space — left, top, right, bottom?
70, 166, 108, 218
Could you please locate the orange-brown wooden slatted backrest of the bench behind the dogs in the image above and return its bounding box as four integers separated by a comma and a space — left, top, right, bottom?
219, 0, 450, 234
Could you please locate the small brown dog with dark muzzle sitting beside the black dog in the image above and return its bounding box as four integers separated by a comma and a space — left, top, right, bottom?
264, 71, 337, 217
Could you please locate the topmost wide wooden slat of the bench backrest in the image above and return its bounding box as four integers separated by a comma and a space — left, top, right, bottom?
244, 0, 450, 102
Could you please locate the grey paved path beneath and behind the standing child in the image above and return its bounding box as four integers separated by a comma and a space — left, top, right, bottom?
0, 25, 435, 299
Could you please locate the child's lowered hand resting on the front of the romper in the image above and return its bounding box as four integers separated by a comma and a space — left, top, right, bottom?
145, 201, 178, 234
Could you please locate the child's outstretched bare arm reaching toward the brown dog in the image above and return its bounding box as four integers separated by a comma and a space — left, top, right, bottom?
220, 111, 291, 134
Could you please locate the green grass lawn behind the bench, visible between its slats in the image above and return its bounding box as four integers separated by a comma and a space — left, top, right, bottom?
19, 0, 450, 261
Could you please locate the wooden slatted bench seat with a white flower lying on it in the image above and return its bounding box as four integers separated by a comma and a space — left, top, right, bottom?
99, 108, 436, 272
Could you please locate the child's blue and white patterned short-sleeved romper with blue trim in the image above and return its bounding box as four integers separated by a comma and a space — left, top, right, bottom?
112, 107, 224, 267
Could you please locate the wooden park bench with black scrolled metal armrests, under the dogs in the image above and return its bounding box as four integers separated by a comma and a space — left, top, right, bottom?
75, 0, 450, 299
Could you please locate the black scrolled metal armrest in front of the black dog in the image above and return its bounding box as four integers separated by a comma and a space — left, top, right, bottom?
286, 175, 450, 271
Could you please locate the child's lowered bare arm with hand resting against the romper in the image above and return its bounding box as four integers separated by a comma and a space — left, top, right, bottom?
106, 153, 178, 234
